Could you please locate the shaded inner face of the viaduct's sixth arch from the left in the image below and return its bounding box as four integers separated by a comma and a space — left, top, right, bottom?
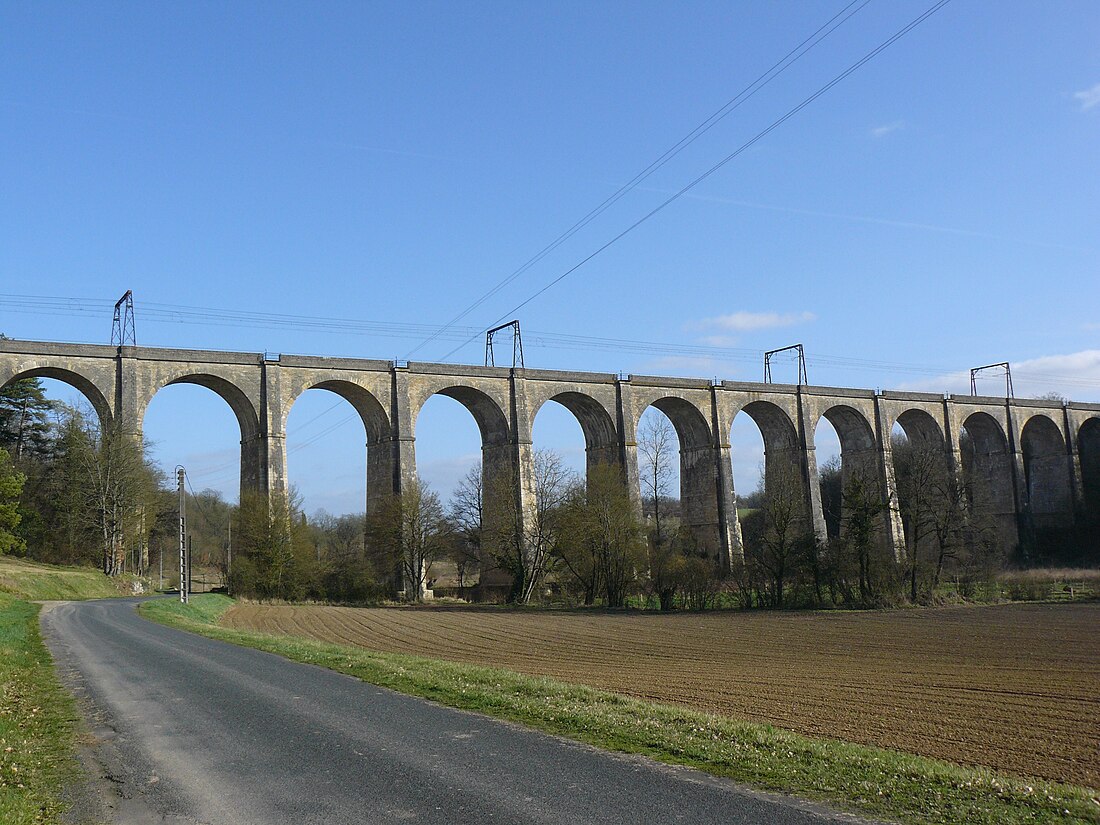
635, 396, 722, 557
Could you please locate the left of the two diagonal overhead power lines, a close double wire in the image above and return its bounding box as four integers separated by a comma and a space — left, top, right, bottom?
405, 0, 871, 360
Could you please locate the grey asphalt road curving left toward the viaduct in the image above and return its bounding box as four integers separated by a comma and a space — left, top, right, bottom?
42, 600, 875, 825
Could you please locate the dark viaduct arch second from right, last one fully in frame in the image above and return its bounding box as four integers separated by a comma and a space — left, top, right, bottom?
1020, 414, 1074, 527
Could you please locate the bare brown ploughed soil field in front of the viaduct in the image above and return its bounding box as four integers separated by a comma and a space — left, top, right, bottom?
223, 604, 1100, 788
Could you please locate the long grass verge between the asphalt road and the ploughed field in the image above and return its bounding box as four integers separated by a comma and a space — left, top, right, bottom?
140, 595, 1100, 825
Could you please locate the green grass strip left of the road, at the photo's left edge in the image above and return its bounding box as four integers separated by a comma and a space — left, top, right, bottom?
0, 593, 78, 825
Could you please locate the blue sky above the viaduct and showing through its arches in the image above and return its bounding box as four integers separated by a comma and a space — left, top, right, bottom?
0, 0, 1100, 512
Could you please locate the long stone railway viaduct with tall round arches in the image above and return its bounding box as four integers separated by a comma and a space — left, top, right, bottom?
0, 340, 1100, 565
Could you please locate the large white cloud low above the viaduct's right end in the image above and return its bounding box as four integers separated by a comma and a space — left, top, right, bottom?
901, 350, 1100, 402
